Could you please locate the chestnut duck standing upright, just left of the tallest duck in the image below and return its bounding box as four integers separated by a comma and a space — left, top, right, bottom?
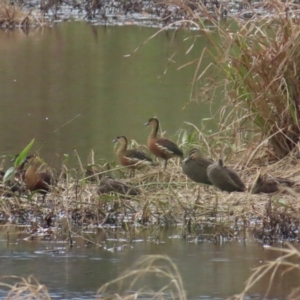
112, 135, 153, 174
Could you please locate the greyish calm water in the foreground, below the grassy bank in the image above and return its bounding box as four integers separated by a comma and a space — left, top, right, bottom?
0, 230, 299, 299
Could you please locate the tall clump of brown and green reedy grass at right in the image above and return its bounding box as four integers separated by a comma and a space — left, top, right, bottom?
162, 0, 300, 159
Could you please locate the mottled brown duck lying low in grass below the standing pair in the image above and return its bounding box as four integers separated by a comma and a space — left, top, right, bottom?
97, 176, 141, 196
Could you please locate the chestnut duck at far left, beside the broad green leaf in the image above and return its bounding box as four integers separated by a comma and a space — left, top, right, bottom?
24, 154, 52, 198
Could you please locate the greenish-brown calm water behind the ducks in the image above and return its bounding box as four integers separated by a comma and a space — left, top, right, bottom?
0, 22, 218, 168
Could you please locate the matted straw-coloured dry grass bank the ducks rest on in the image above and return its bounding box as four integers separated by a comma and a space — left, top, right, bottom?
0, 141, 300, 246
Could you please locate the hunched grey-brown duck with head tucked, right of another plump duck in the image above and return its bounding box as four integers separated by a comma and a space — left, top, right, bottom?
207, 159, 246, 193
